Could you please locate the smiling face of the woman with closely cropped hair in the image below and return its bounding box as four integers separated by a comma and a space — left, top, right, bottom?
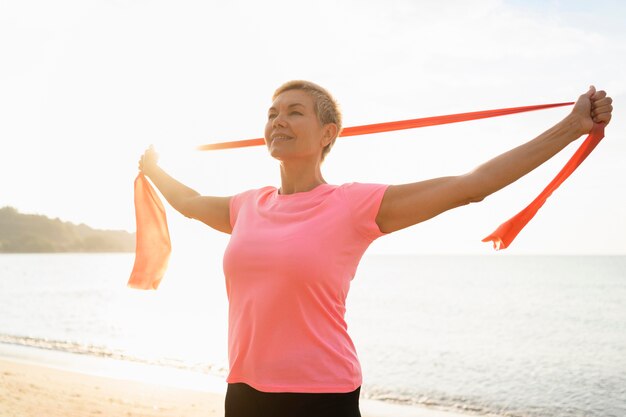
265, 90, 330, 161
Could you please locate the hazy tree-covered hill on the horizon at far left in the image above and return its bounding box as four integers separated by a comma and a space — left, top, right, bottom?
0, 206, 135, 253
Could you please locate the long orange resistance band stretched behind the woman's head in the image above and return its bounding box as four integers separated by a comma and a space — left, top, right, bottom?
128, 102, 604, 289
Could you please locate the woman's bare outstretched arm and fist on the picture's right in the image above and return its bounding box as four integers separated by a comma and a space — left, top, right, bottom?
376, 86, 613, 233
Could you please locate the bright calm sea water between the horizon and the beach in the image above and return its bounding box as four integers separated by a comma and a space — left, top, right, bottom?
0, 250, 626, 417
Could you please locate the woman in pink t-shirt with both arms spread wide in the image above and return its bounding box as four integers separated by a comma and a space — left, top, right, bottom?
139, 81, 612, 417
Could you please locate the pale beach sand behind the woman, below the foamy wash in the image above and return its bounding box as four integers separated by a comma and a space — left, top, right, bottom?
0, 359, 472, 417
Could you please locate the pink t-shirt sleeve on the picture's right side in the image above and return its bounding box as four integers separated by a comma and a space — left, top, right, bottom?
341, 182, 389, 240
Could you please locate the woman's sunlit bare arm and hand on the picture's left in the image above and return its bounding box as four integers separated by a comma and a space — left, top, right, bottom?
139, 147, 232, 234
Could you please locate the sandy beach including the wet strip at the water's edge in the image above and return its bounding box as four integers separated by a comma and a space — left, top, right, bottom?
0, 344, 478, 417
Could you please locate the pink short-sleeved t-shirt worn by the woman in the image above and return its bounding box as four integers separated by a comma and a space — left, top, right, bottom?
224, 183, 387, 393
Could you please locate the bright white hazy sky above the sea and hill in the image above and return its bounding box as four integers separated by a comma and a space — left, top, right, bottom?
0, 0, 626, 254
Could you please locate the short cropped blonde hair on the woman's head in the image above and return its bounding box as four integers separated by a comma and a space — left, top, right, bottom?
272, 80, 342, 161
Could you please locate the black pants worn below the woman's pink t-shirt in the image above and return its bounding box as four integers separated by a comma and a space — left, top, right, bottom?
225, 383, 361, 417
